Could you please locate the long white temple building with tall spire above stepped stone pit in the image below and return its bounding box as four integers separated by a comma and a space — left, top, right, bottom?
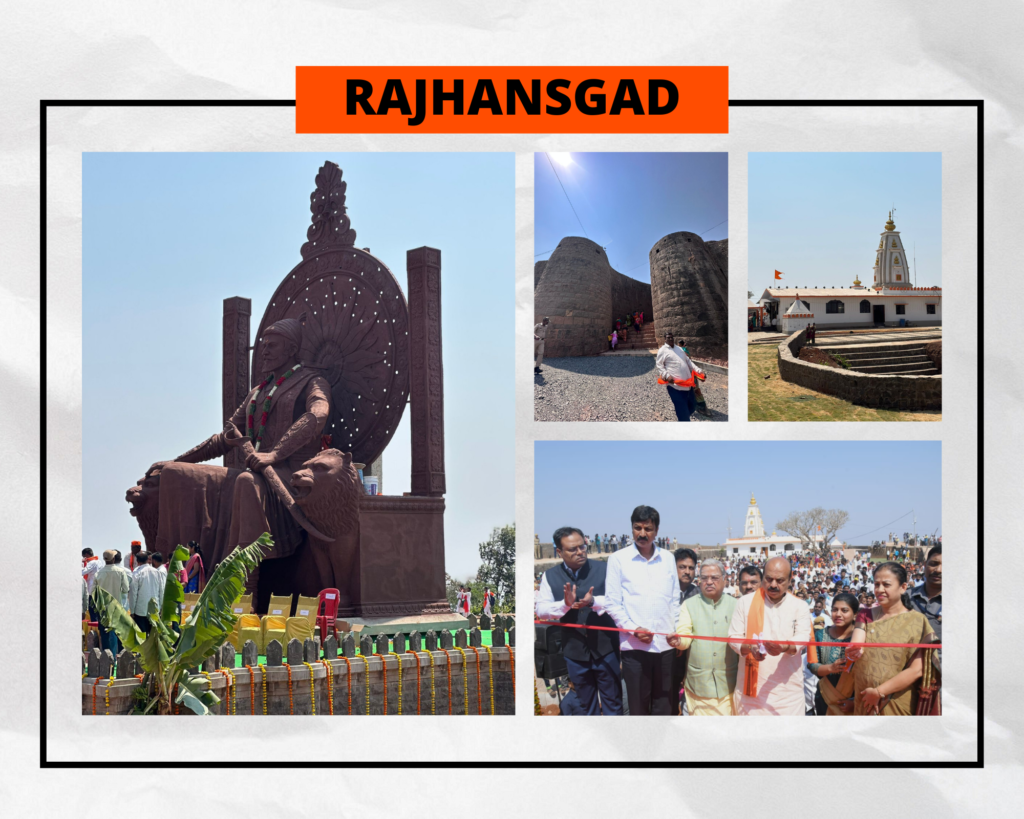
759, 212, 942, 333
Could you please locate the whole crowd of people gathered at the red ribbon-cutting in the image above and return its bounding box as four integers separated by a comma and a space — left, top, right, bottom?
536, 506, 942, 716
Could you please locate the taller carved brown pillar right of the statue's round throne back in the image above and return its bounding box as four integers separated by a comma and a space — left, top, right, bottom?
406, 248, 445, 498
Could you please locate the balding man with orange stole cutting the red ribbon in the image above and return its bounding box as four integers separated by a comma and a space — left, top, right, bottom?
729, 557, 817, 717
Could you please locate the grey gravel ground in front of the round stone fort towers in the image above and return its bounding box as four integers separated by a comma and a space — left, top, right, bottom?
534, 355, 729, 423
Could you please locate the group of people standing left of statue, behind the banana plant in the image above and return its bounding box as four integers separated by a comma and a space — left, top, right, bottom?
82, 541, 206, 655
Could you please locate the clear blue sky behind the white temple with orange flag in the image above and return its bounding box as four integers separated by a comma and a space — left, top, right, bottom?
748, 153, 942, 300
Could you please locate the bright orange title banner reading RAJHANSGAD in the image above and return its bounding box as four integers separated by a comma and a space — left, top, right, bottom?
295, 66, 729, 134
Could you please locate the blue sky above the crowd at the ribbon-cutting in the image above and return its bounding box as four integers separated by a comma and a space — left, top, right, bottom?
535, 441, 942, 546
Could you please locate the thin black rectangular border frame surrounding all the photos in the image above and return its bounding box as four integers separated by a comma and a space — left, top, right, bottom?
39, 99, 985, 770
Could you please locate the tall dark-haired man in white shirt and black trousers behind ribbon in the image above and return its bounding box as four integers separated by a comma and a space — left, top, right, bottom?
604, 506, 679, 717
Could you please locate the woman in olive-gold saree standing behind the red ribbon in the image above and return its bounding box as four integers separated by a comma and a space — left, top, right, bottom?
846, 563, 934, 717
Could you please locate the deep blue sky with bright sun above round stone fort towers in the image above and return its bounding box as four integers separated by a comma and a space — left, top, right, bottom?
534, 153, 729, 282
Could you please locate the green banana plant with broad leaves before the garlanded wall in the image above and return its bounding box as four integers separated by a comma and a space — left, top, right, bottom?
93, 532, 273, 716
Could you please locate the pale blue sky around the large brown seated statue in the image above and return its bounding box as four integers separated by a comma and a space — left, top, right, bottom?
82, 153, 515, 576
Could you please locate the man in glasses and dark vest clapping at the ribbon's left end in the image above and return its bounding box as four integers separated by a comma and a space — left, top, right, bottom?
537, 526, 623, 717
